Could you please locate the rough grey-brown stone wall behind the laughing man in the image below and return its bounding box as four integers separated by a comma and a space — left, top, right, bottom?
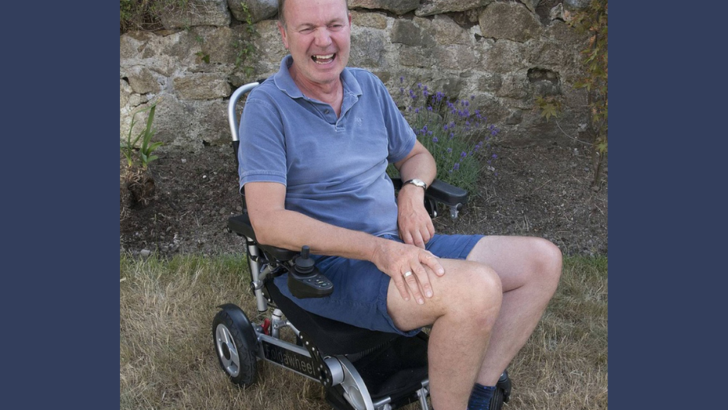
119, 0, 587, 149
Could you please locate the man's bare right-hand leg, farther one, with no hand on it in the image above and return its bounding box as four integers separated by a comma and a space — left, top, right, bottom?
467, 236, 561, 386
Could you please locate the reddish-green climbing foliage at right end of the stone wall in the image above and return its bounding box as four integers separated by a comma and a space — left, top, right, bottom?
569, 0, 609, 183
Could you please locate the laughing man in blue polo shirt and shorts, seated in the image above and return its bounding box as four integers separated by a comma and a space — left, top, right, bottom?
238, 0, 561, 410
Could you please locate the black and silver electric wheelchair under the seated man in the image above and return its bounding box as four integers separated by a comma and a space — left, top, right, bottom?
212, 80, 511, 410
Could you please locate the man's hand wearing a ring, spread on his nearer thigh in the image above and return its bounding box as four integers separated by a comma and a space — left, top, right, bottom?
371, 239, 445, 304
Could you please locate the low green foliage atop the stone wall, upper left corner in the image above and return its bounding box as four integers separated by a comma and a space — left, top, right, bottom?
119, 0, 189, 33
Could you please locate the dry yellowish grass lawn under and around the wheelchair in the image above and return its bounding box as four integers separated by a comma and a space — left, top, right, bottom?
119, 255, 608, 410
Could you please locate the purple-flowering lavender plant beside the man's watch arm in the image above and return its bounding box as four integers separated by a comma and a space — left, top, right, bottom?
390, 77, 499, 194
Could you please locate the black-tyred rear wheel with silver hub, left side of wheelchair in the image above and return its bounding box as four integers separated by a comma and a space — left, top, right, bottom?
212, 310, 257, 386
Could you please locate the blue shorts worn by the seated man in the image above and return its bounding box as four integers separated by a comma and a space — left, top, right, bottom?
275, 234, 483, 336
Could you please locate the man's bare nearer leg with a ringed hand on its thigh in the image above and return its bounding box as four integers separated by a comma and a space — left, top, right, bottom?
387, 259, 503, 410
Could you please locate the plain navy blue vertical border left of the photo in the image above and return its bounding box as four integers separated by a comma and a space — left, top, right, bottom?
0, 1, 119, 409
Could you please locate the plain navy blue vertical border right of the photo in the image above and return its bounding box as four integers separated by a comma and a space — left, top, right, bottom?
609, 2, 728, 409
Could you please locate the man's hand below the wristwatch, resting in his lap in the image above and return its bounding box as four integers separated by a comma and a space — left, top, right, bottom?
397, 185, 435, 249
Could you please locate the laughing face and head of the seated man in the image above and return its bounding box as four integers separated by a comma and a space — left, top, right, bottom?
278, 0, 351, 84
